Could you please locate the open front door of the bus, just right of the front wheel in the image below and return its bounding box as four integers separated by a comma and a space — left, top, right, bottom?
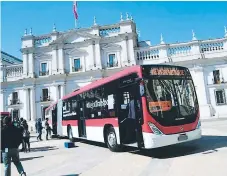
118, 84, 143, 148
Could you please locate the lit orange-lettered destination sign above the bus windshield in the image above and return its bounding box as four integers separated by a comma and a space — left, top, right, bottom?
150, 67, 187, 76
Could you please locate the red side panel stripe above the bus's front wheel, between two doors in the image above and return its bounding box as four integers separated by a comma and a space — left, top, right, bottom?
86, 117, 119, 127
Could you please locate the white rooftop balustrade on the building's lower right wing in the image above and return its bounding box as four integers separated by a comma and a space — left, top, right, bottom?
135, 38, 227, 65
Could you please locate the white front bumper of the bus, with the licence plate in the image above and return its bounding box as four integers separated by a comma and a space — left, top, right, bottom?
143, 128, 202, 149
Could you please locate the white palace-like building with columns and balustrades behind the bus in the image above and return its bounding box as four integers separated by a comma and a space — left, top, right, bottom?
0, 17, 227, 129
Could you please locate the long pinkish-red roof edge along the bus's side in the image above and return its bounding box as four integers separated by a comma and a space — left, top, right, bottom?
45, 65, 141, 111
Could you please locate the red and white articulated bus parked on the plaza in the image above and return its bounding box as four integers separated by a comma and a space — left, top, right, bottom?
46, 65, 201, 151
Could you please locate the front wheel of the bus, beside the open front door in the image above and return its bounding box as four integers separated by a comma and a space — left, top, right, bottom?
105, 127, 121, 152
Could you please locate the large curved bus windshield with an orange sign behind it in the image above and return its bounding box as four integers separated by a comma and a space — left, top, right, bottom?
145, 76, 198, 126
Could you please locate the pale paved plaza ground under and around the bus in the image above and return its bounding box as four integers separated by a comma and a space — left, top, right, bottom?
1, 120, 227, 176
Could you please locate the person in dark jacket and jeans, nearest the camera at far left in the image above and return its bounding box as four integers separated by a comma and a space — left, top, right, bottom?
1, 118, 26, 176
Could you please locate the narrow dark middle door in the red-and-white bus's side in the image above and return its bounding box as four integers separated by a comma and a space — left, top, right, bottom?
78, 102, 87, 138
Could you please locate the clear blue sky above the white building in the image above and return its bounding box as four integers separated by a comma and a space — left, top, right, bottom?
1, 1, 227, 59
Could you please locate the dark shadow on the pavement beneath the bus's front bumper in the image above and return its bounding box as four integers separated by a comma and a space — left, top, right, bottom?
128, 135, 227, 159
